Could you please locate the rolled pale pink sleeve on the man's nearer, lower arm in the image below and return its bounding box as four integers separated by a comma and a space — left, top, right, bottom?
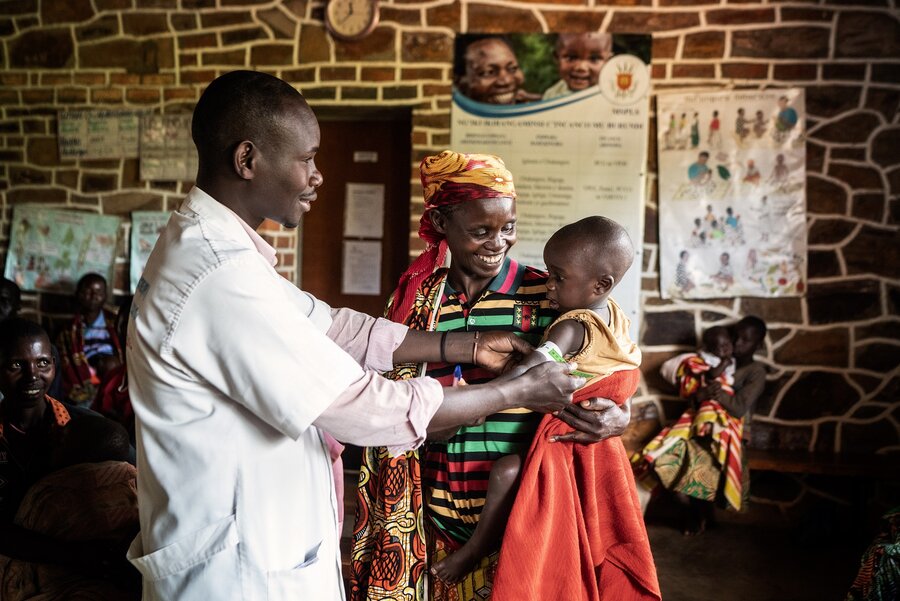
315, 368, 444, 453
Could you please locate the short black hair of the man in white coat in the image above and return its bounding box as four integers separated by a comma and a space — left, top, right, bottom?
191, 71, 312, 166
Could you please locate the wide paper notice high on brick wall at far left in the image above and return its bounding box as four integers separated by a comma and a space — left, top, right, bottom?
59, 110, 145, 159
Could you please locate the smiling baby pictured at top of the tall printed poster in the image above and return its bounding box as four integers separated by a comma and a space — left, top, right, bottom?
543, 33, 613, 100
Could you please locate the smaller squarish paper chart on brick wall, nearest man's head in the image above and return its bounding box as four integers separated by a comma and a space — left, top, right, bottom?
140, 114, 197, 181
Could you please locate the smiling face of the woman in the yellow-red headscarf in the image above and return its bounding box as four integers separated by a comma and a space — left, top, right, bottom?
432, 196, 516, 286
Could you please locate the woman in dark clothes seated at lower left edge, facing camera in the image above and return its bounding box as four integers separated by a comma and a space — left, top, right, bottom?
0, 318, 133, 601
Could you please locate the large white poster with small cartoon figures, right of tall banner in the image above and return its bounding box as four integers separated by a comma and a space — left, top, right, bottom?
657, 88, 806, 298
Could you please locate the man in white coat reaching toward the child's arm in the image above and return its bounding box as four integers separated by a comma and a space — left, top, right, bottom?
127, 71, 582, 601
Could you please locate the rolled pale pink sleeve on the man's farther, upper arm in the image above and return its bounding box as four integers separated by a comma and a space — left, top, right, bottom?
326, 308, 409, 371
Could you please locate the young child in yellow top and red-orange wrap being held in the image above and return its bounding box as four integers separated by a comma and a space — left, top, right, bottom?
433, 217, 660, 601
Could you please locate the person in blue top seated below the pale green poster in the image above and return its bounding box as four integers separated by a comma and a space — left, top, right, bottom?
56, 273, 122, 405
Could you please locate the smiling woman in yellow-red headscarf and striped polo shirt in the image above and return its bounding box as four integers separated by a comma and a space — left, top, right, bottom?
350, 151, 628, 601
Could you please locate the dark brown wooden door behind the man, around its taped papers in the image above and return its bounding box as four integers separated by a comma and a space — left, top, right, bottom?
299, 108, 411, 316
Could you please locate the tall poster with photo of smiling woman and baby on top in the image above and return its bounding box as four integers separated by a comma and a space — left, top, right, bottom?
450, 33, 651, 339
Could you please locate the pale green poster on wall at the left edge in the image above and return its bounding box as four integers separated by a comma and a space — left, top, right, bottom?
4, 205, 121, 294
